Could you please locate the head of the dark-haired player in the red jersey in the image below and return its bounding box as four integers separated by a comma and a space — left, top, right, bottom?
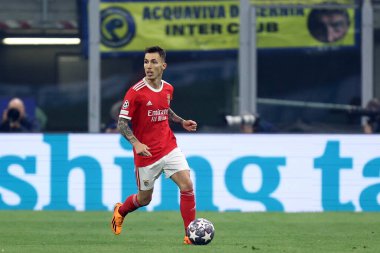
144, 53, 166, 80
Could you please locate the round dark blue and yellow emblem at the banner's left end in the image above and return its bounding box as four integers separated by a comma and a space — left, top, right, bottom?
100, 7, 136, 48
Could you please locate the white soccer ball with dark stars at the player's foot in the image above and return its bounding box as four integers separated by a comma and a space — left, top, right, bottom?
186, 218, 215, 245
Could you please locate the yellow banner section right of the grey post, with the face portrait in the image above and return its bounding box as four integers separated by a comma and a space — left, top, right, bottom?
256, 8, 355, 48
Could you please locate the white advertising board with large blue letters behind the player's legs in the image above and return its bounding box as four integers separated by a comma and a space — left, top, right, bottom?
0, 134, 380, 212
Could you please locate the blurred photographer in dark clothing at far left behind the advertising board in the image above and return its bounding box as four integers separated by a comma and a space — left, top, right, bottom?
0, 98, 40, 132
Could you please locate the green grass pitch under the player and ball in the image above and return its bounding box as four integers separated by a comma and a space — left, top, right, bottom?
0, 211, 380, 253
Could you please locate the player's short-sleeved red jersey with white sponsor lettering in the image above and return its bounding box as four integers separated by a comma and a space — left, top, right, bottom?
119, 78, 177, 167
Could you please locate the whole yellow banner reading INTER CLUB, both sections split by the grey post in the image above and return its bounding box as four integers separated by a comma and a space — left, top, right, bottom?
100, 1, 355, 53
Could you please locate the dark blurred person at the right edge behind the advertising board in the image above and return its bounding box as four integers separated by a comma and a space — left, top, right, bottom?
363, 98, 380, 134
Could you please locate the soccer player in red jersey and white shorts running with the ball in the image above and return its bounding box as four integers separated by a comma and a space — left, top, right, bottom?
111, 46, 197, 244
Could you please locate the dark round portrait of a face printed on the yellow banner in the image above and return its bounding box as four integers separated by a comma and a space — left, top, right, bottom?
307, 9, 350, 43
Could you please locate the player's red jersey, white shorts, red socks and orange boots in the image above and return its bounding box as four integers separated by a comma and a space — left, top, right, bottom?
116, 78, 195, 237
